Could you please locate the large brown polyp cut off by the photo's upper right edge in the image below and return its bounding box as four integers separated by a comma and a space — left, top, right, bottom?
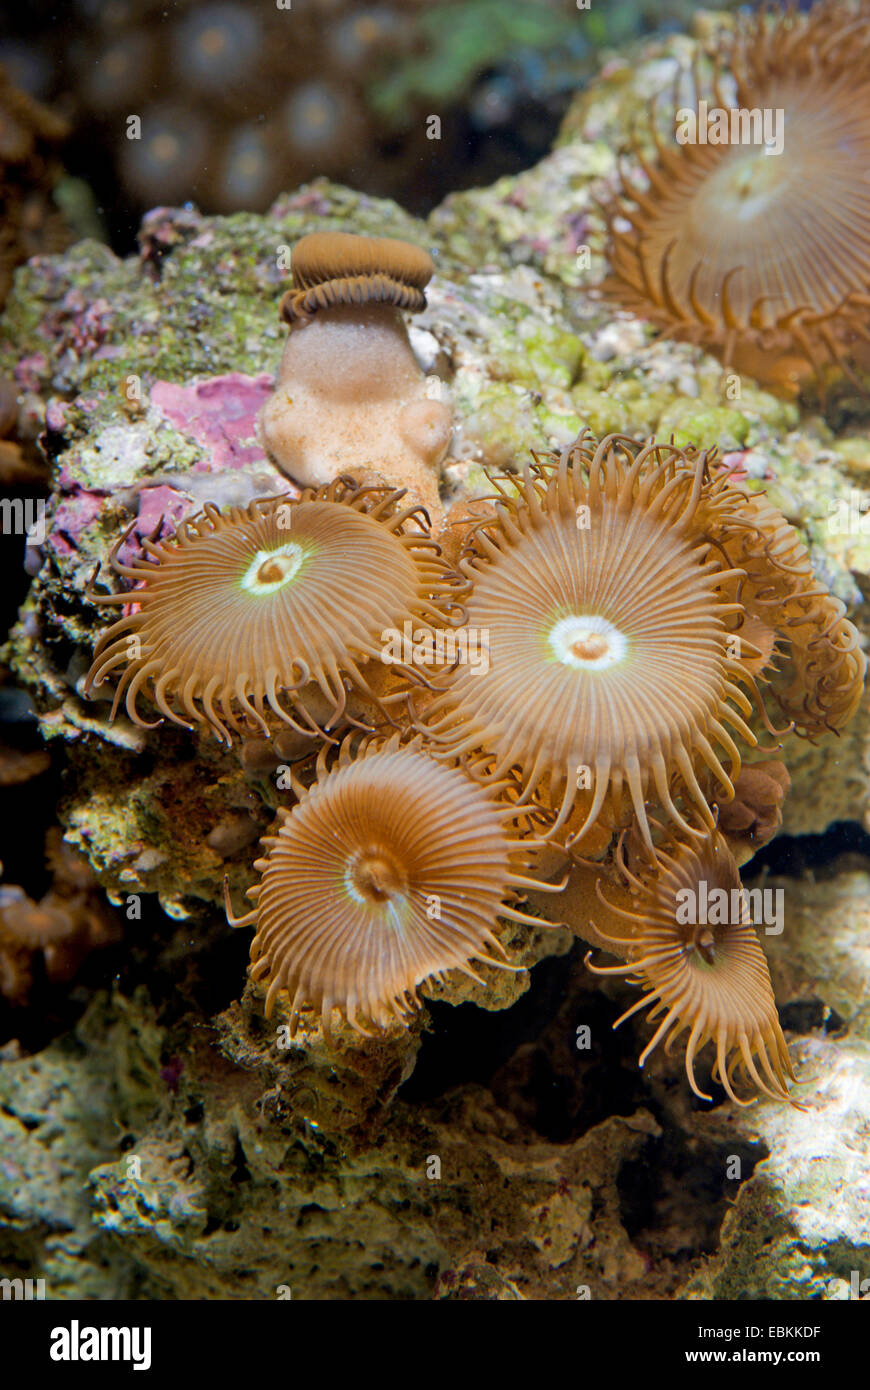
602, 0, 870, 395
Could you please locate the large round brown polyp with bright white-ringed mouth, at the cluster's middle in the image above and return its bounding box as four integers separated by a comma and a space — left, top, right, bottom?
420, 434, 755, 841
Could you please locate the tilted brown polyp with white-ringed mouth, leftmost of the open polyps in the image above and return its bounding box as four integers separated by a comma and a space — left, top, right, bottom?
85, 478, 456, 744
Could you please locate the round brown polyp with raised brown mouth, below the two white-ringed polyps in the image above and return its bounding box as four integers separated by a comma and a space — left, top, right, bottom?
227, 734, 559, 1034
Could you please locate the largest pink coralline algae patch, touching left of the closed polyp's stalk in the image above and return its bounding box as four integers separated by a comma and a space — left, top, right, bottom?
149, 373, 272, 473
